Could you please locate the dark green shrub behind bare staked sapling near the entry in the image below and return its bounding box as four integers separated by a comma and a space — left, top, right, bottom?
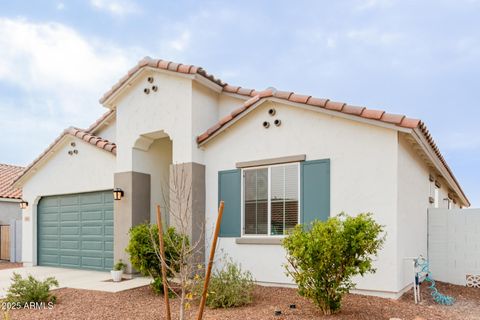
126, 223, 188, 293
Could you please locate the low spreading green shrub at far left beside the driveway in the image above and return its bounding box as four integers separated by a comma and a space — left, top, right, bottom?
6, 273, 58, 306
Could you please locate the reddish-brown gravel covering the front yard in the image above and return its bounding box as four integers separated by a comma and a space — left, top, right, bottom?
4, 283, 480, 320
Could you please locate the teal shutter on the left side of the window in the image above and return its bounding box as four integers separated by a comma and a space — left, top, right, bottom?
218, 169, 242, 237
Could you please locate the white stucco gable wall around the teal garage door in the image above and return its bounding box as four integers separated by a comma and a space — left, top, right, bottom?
22, 136, 115, 265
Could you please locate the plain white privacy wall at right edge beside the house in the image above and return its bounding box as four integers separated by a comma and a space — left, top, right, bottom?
428, 209, 480, 285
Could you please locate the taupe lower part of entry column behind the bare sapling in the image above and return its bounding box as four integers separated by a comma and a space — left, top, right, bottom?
169, 162, 206, 263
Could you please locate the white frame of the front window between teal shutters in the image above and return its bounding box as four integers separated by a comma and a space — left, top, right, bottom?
240, 162, 302, 238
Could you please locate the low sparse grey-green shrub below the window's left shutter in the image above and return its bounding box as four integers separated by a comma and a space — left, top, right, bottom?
193, 260, 254, 308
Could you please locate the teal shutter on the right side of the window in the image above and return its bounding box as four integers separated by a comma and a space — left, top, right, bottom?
300, 159, 330, 225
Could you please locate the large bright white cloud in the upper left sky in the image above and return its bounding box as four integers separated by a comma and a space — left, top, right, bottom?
0, 18, 140, 111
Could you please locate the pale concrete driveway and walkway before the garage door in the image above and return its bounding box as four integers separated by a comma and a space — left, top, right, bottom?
0, 266, 151, 298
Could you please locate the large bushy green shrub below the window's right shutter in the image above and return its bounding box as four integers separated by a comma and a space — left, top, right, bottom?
283, 213, 385, 314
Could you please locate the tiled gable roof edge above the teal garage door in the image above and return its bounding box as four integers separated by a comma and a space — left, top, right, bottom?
14, 127, 117, 183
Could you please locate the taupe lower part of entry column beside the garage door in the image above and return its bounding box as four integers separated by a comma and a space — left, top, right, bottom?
113, 171, 150, 274
